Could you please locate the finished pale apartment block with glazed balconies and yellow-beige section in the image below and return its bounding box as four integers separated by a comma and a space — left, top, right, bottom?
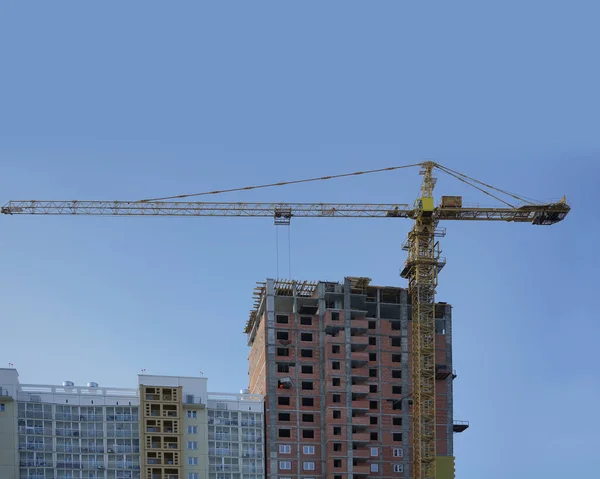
0, 369, 264, 479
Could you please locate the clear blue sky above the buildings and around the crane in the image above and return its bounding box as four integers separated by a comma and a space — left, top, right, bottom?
0, 0, 600, 479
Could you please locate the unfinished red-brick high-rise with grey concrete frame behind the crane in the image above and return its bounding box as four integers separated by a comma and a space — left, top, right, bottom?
245, 278, 462, 479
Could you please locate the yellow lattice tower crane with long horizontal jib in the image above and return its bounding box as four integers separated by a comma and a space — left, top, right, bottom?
0, 161, 570, 479
